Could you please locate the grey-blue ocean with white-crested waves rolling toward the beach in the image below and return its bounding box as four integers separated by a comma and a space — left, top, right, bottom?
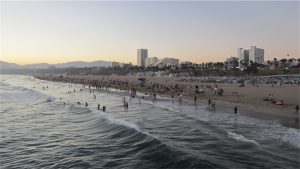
0, 75, 300, 169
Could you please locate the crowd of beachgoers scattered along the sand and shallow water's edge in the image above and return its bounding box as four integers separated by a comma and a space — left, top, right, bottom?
37, 76, 298, 117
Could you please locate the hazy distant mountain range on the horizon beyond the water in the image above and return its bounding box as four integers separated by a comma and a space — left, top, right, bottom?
0, 60, 111, 70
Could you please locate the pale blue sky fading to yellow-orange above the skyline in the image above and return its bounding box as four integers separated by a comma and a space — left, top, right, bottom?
0, 1, 300, 64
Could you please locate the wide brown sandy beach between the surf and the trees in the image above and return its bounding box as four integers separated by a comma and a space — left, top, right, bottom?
36, 75, 299, 128
